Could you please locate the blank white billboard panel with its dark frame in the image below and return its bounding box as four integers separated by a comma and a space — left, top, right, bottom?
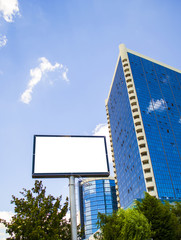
32, 135, 109, 178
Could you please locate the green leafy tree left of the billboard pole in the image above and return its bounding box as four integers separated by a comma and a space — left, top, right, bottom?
0, 181, 71, 240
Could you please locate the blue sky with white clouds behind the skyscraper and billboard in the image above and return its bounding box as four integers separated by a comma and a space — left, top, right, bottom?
0, 0, 181, 239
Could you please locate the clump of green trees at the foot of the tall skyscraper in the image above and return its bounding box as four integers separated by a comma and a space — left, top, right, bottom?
95, 193, 181, 240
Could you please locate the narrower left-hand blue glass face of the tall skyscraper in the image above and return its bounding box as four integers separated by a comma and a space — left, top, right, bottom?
108, 57, 146, 207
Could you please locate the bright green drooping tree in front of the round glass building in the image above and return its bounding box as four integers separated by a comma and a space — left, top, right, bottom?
95, 209, 151, 240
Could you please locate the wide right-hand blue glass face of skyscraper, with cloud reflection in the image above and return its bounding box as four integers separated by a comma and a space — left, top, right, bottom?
128, 53, 181, 199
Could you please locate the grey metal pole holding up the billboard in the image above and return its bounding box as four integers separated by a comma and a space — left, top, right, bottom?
69, 176, 77, 240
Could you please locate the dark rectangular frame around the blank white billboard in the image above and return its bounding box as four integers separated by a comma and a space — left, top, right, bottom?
32, 135, 110, 178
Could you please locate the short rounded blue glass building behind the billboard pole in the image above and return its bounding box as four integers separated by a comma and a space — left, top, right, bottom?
79, 177, 117, 239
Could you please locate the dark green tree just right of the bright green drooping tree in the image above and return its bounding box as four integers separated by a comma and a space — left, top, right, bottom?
136, 193, 177, 240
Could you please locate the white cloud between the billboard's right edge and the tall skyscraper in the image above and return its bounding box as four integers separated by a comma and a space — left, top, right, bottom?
93, 123, 112, 162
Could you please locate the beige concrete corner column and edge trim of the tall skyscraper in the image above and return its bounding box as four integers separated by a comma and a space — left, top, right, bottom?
106, 44, 174, 206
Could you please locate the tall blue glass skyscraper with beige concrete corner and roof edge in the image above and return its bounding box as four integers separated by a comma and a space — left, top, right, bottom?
106, 44, 181, 208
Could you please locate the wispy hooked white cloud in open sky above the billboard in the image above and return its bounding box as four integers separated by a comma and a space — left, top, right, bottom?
21, 57, 69, 104
